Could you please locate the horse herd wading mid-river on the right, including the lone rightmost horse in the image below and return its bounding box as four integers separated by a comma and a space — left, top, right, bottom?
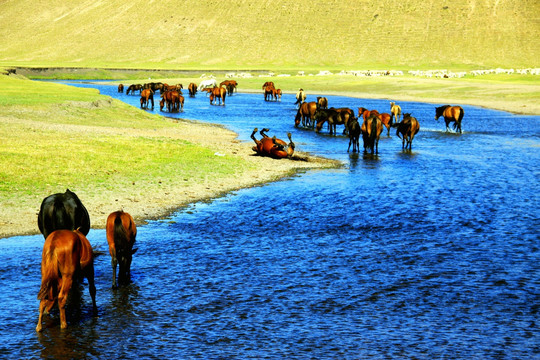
294, 89, 464, 154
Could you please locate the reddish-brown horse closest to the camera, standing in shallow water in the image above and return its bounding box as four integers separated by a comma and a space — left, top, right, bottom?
36, 230, 97, 331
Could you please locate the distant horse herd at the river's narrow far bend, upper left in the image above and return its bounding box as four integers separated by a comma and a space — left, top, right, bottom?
118, 79, 238, 112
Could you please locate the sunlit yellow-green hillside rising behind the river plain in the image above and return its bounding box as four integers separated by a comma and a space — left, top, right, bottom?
0, 0, 540, 70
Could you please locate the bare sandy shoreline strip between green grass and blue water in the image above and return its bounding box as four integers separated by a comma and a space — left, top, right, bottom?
0, 117, 342, 239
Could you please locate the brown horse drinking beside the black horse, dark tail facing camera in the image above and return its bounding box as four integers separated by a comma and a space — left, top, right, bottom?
106, 211, 137, 288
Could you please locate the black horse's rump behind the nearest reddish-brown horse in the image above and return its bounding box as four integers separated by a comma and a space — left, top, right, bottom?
38, 189, 90, 239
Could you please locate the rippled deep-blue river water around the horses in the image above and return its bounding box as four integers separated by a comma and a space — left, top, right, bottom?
0, 83, 540, 359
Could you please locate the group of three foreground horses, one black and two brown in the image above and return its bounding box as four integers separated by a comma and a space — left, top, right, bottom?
36, 189, 137, 332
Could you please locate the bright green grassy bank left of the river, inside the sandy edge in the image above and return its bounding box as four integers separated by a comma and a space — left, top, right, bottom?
0, 76, 248, 219
